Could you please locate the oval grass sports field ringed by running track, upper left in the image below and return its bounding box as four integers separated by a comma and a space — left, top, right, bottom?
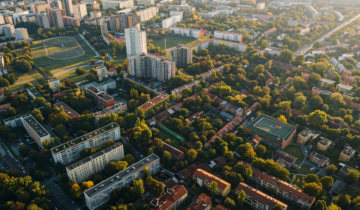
42, 36, 85, 60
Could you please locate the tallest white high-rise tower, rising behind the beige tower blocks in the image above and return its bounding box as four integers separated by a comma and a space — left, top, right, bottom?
124, 28, 147, 58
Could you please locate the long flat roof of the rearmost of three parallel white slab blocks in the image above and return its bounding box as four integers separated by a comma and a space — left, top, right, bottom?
51, 122, 119, 154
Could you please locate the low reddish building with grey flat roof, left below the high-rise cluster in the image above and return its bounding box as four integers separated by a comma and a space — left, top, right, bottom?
86, 86, 115, 110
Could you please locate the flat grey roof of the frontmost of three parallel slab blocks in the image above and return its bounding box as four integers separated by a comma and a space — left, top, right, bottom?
84, 154, 159, 198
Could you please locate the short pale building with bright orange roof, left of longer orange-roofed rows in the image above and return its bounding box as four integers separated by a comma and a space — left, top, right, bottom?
192, 169, 231, 196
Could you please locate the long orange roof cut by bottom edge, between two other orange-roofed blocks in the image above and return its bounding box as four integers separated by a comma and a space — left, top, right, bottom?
236, 182, 287, 209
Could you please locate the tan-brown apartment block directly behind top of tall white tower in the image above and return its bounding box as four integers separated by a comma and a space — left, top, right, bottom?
110, 13, 140, 32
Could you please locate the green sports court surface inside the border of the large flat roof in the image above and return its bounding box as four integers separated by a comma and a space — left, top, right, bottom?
254, 118, 294, 139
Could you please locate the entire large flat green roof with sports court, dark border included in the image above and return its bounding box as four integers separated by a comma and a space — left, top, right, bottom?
246, 114, 296, 143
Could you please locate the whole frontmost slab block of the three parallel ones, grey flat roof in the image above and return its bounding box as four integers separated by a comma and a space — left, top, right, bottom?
84, 154, 160, 210
